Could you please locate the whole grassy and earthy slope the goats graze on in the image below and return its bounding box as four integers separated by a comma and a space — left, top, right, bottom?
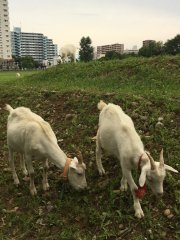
0, 57, 180, 240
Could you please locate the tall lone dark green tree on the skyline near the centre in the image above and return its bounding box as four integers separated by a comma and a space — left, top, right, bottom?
79, 37, 93, 62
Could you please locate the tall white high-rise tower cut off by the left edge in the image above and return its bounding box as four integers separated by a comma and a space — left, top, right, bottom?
0, 0, 12, 60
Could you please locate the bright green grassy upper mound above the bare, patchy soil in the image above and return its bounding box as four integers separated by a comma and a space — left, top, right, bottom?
0, 55, 180, 97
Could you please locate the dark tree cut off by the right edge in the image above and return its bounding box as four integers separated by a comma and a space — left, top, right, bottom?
164, 34, 180, 55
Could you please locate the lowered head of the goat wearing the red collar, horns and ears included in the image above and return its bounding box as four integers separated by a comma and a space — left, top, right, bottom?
139, 149, 178, 196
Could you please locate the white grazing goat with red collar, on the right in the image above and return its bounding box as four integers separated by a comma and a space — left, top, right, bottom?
96, 101, 178, 218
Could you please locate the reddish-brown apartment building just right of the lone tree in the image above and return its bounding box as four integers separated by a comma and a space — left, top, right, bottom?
97, 43, 124, 58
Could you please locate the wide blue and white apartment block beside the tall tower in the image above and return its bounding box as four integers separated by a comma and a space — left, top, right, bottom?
11, 27, 58, 63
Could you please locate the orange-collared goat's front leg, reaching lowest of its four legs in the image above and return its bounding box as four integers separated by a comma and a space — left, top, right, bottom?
25, 155, 37, 196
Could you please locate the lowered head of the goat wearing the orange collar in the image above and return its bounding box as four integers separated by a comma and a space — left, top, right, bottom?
68, 152, 87, 190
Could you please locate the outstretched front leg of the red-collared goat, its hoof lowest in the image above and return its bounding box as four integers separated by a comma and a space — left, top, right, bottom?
123, 169, 144, 218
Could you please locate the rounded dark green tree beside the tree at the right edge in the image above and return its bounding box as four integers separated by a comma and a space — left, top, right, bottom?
139, 41, 163, 57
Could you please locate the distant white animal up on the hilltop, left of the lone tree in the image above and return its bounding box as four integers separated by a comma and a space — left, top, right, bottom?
59, 44, 76, 63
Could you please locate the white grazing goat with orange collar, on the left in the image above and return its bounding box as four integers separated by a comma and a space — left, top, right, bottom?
5, 105, 87, 195
